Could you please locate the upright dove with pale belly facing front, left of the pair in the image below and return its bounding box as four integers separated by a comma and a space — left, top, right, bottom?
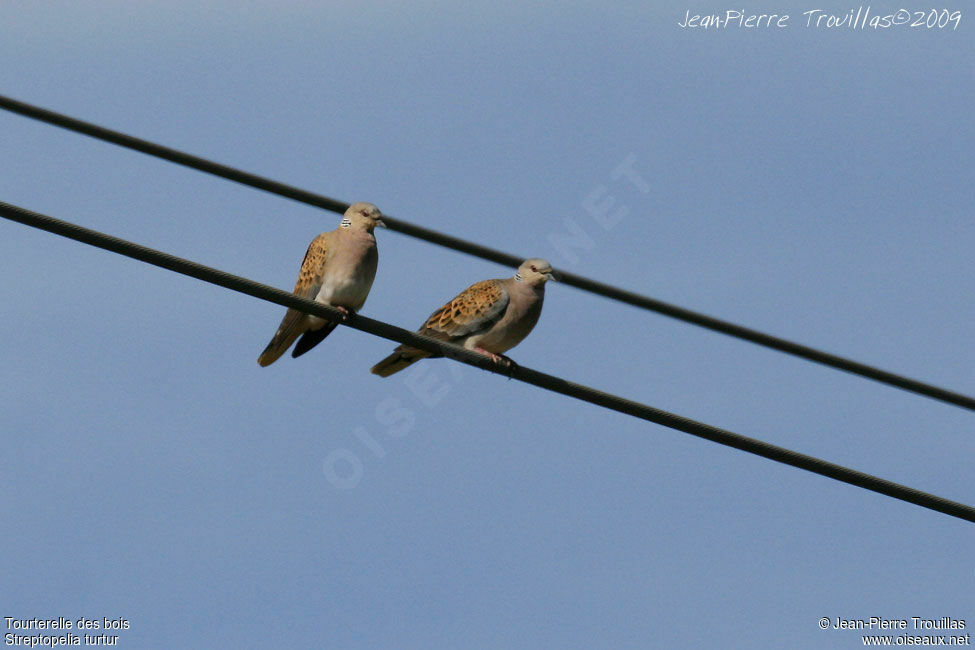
257, 203, 386, 366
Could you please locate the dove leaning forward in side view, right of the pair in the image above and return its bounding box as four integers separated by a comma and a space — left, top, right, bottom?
372, 259, 555, 377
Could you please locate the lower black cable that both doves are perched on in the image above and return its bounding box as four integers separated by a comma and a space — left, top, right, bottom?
0, 197, 975, 522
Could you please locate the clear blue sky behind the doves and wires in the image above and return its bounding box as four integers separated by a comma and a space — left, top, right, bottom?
0, 0, 975, 648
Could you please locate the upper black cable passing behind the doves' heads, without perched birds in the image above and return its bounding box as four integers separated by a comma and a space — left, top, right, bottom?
0, 95, 975, 411
